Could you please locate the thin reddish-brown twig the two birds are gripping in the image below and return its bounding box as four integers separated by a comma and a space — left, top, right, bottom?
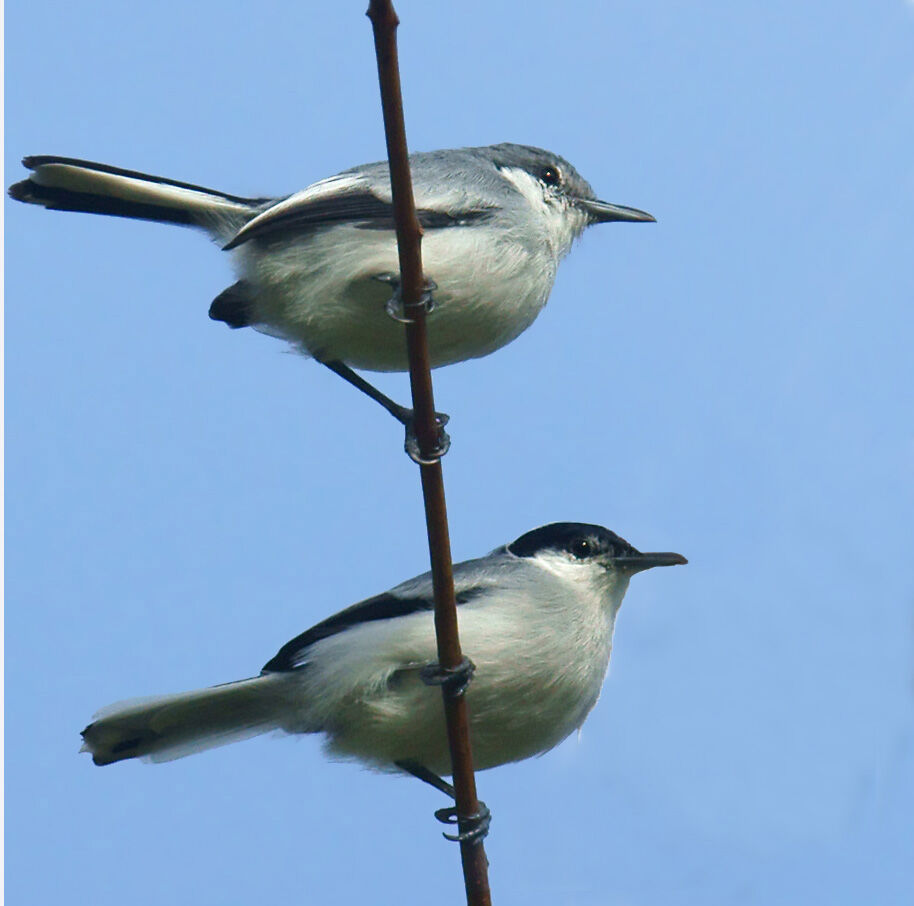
368, 0, 491, 906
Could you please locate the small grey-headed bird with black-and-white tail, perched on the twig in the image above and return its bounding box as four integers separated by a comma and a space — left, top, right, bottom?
9, 143, 654, 444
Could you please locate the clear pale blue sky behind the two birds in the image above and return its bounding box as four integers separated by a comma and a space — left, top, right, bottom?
5, 0, 914, 906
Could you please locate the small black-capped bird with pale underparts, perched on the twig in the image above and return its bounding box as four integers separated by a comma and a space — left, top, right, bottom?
82, 522, 688, 820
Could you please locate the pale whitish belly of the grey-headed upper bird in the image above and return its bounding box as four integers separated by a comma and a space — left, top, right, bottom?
235, 222, 555, 371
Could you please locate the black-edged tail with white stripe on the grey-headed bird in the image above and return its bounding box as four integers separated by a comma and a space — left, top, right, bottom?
9, 156, 270, 236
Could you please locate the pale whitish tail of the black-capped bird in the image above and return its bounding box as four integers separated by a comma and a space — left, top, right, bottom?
82, 673, 295, 765
